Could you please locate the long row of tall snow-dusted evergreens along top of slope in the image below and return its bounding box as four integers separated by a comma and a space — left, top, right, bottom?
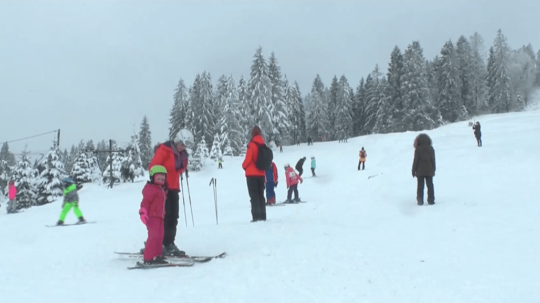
170, 30, 540, 150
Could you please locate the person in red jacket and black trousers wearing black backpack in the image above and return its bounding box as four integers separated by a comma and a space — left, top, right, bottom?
242, 126, 266, 222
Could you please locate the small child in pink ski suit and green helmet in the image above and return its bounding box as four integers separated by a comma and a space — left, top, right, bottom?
139, 165, 168, 265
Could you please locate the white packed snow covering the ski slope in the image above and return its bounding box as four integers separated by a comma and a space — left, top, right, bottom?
0, 110, 540, 303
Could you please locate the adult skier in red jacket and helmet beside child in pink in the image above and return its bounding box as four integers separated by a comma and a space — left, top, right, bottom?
148, 135, 189, 256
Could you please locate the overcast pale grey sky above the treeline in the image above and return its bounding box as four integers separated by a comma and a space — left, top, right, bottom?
0, 0, 540, 157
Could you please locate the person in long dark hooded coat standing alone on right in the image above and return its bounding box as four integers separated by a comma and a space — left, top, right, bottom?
412, 134, 435, 205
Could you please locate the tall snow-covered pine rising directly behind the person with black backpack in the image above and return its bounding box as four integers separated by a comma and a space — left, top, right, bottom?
248, 47, 274, 142
